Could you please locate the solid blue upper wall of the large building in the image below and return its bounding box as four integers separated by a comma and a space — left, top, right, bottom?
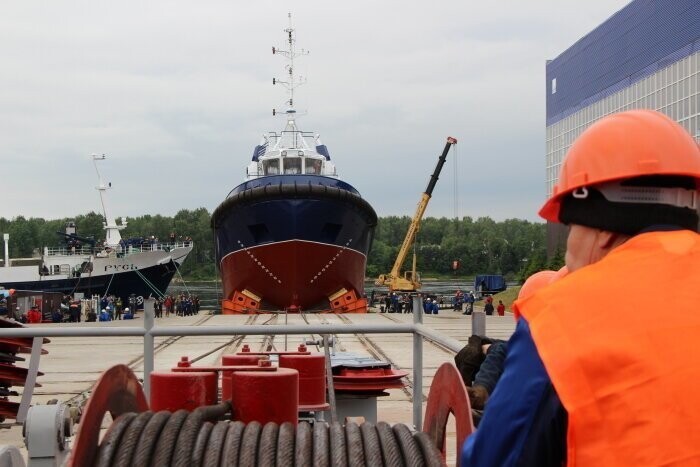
547, 0, 700, 126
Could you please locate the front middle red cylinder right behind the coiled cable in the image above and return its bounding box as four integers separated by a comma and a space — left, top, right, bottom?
231, 368, 299, 426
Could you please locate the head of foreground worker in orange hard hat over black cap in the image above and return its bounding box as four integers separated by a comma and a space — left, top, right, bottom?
540, 110, 700, 272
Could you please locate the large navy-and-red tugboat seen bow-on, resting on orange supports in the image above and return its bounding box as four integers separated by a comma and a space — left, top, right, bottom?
212, 19, 377, 314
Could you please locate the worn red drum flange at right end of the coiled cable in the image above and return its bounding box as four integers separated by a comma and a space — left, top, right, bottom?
423, 362, 474, 465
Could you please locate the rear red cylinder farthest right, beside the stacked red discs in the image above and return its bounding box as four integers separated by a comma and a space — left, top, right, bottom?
279, 354, 328, 410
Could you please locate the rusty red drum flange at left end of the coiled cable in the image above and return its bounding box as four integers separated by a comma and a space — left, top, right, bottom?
68, 365, 148, 467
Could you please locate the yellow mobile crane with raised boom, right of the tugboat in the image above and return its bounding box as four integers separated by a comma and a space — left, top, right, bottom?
374, 136, 457, 292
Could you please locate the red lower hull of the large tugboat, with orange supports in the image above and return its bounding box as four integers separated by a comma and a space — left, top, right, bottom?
220, 240, 367, 314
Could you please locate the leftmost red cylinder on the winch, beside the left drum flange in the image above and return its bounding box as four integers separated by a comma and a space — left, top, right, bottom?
151, 371, 218, 412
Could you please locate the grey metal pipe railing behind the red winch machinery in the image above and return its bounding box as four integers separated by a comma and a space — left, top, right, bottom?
0, 295, 454, 429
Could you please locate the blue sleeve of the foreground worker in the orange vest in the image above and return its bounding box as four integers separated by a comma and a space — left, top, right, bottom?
461, 318, 567, 467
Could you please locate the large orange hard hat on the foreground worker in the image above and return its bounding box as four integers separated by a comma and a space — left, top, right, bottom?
539, 110, 700, 222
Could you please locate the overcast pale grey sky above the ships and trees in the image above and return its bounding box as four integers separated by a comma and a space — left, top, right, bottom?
0, 0, 628, 220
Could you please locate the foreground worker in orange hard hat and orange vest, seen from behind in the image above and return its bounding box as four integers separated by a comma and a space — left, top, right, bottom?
462, 110, 700, 466
